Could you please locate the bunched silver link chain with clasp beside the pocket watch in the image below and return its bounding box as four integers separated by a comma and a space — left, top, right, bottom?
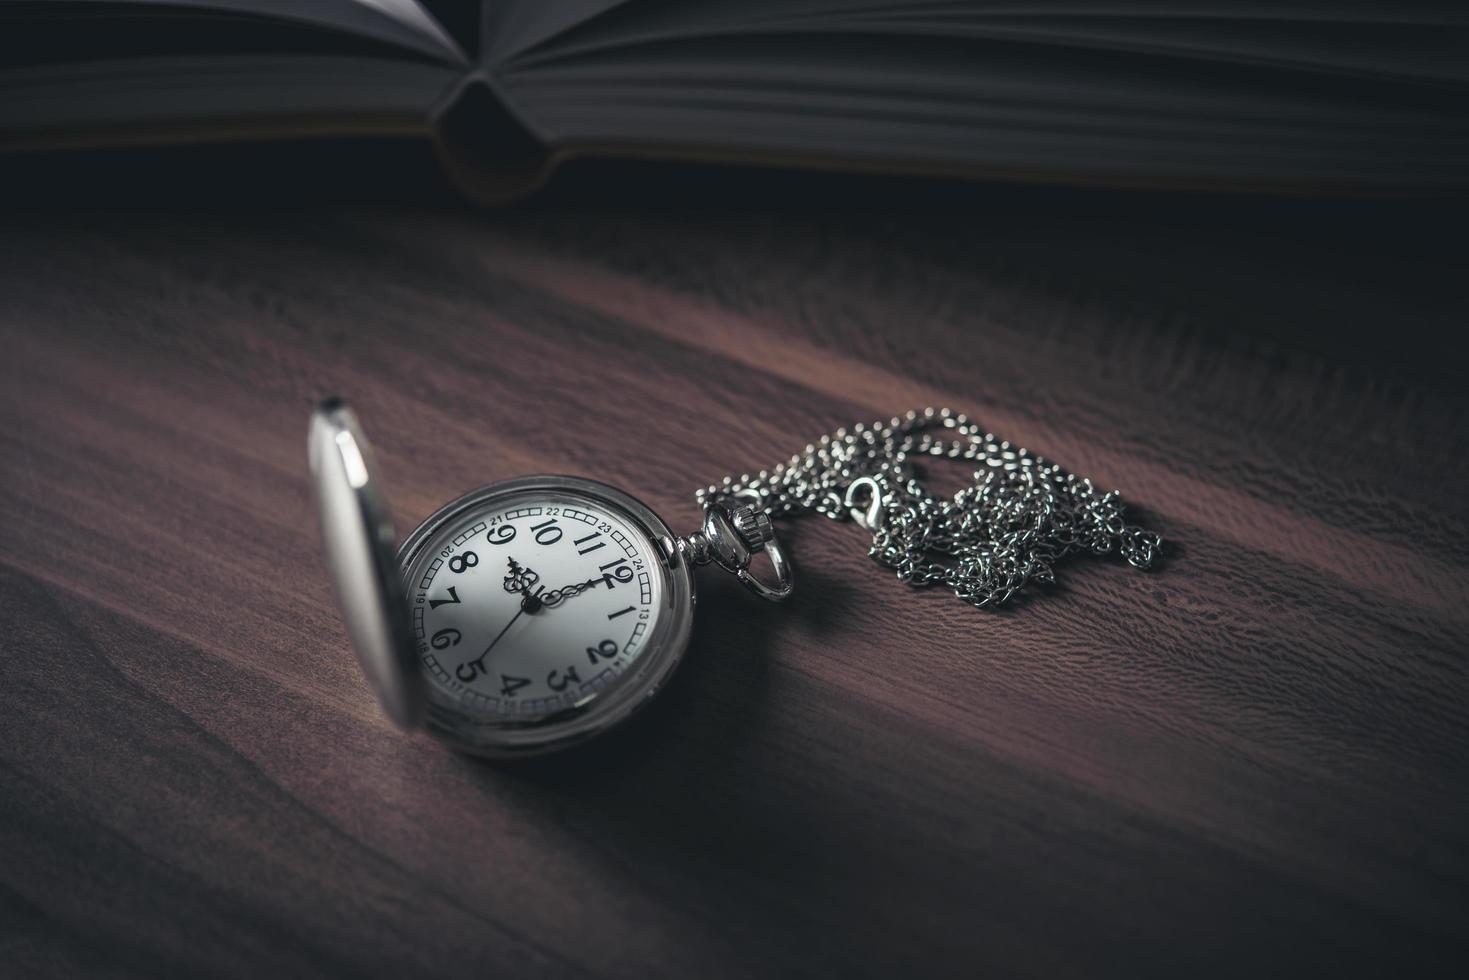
696, 408, 1162, 608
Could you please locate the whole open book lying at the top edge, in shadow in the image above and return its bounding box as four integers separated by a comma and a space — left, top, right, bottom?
0, 0, 1469, 200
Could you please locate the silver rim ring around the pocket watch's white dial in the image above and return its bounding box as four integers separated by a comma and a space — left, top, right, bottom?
398, 475, 696, 758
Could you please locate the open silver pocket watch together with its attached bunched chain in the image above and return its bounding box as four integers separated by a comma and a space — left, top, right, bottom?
308, 400, 1162, 757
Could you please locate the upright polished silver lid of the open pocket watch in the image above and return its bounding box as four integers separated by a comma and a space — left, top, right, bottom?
307, 398, 425, 729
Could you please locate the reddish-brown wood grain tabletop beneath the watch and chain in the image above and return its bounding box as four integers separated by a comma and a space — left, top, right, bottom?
0, 170, 1469, 977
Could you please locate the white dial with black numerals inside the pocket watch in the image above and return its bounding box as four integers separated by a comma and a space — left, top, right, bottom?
404, 489, 668, 721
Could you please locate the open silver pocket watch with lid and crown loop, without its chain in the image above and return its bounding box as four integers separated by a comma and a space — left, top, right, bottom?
308, 400, 792, 757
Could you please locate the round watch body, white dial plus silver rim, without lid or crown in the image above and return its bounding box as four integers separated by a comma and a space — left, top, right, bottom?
403, 478, 693, 751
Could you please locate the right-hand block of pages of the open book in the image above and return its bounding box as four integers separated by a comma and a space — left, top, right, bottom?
497, 0, 1469, 190
